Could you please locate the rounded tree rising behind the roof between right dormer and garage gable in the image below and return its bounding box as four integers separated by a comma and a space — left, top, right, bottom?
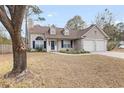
66, 15, 85, 31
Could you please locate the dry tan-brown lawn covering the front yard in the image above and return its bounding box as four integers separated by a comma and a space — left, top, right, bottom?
0, 53, 124, 87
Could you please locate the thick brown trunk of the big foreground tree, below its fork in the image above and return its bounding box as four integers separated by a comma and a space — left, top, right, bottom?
5, 31, 27, 77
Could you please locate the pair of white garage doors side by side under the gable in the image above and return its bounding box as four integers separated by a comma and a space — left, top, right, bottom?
83, 40, 106, 51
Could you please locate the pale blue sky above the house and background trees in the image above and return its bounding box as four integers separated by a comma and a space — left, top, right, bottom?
32, 5, 124, 27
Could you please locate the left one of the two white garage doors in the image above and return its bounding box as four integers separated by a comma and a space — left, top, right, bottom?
83, 40, 95, 51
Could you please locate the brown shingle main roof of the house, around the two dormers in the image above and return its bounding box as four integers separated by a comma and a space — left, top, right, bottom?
29, 25, 95, 39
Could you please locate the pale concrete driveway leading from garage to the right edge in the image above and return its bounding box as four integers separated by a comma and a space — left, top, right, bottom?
92, 51, 124, 59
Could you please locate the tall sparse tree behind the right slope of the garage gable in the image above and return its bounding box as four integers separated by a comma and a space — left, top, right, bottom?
95, 9, 119, 41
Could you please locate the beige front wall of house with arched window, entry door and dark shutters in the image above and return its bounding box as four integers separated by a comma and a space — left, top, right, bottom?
30, 36, 77, 52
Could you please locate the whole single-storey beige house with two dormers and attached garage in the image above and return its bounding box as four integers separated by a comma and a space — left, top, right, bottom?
29, 25, 109, 52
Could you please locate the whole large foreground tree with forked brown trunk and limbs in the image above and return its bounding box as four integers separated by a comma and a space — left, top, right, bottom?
0, 5, 27, 77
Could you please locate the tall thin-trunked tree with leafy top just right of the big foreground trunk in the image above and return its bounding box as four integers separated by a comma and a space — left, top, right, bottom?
25, 5, 45, 48
